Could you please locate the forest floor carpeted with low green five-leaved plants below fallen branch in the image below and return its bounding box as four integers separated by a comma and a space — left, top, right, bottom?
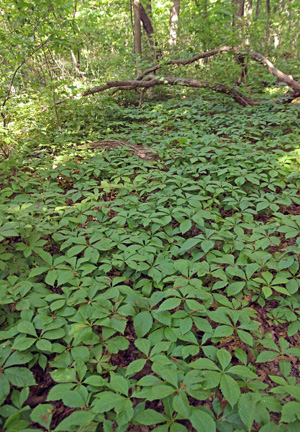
0, 92, 300, 432
